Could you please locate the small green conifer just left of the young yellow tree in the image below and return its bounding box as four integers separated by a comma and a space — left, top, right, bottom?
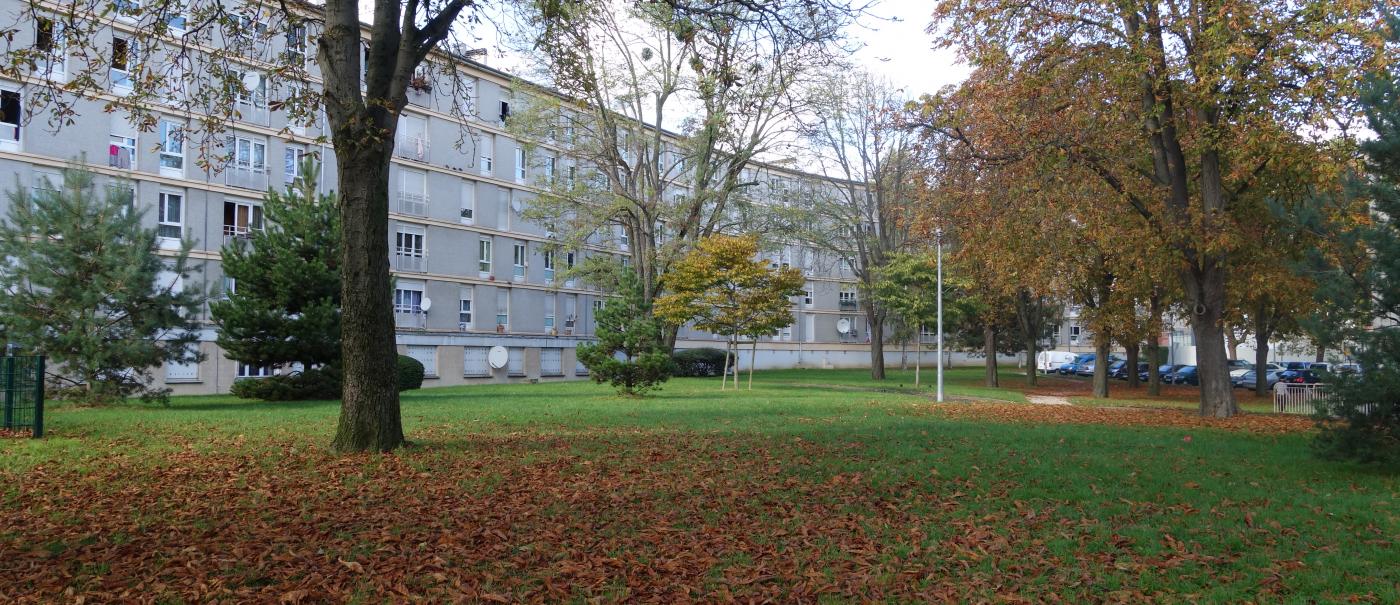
578, 269, 671, 396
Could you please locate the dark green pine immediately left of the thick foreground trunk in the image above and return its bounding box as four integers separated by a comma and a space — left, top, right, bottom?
210, 160, 340, 399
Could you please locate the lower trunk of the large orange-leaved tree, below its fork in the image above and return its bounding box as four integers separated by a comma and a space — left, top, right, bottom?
1183, 261, 1239, 417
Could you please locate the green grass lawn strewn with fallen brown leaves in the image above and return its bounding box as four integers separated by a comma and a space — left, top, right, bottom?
0, 370, 1400, 602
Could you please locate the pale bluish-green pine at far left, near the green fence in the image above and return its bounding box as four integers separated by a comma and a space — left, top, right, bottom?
0, 168, 204, 403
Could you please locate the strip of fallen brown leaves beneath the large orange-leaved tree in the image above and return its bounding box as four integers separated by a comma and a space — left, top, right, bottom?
928, 403, 1316, 434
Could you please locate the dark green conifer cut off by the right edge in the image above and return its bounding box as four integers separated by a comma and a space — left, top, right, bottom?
1316, 17, 1400, 469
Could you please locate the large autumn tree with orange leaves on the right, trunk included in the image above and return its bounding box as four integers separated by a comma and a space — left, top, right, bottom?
924, 0, 1385, 417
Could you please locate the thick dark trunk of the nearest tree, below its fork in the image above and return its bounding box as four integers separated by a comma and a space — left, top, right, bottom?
330, 144, 403, 451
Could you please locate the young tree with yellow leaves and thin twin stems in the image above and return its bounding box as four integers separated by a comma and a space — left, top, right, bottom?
655, 235, 806, 389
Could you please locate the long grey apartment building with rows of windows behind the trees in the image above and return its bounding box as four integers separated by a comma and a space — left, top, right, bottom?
0, 0, 899, 394
